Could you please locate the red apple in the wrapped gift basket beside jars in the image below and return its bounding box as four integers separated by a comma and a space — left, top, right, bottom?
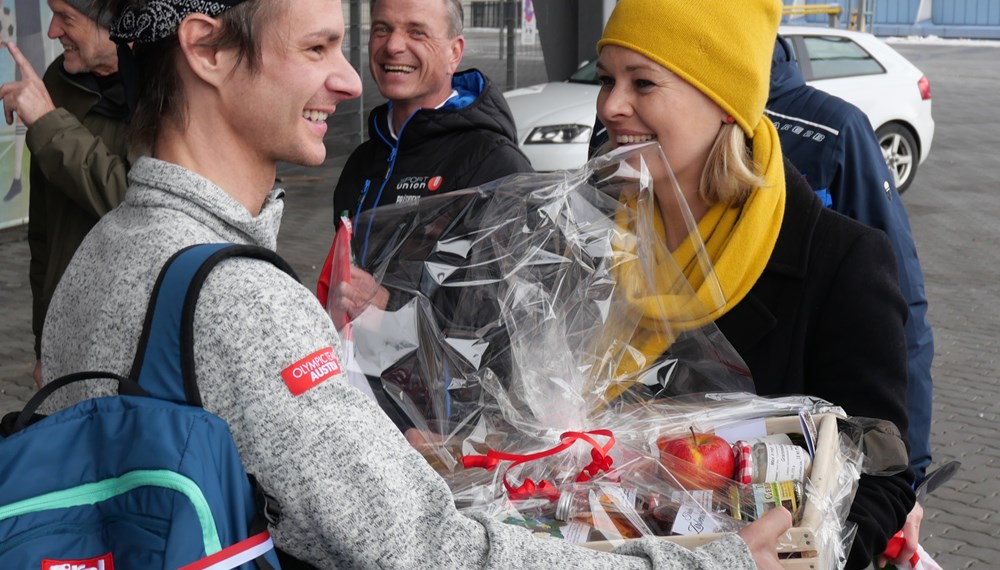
656, 429, 736, 489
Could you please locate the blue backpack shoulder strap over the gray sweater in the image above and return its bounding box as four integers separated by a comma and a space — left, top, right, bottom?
129, 243, 298, 407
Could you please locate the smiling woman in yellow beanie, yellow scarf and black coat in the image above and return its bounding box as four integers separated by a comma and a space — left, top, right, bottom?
597, 0, 915, 569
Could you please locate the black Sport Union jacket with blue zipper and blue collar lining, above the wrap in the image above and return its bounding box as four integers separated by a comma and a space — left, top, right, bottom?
333, 69, 532, 261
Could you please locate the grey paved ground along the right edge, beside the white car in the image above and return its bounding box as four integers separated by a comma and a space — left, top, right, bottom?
894, 43, 1000, 569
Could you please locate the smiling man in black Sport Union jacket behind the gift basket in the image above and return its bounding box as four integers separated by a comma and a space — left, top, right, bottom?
333, 0, 532, 270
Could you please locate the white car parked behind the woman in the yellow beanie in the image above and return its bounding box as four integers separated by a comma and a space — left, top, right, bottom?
504, 26, 934, 192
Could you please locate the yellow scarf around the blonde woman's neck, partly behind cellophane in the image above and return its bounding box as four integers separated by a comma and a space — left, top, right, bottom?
600, 119, 785, 394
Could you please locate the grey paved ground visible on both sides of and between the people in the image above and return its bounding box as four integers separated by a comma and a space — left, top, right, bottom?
0, 43, 1000, 569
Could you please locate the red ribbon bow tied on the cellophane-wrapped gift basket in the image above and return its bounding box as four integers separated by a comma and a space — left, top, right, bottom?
461, 429, 615, 501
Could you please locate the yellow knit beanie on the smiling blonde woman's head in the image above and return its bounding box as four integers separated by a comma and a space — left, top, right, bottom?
597, 0, 781, 137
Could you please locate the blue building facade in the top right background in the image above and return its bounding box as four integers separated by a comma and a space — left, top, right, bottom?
784, 0, 1000, 40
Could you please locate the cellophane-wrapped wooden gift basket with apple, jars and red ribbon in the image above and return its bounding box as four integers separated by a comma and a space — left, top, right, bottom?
331, 144, 876, 569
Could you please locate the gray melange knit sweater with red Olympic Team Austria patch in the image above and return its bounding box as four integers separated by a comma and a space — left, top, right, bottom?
42, 158, 754, 570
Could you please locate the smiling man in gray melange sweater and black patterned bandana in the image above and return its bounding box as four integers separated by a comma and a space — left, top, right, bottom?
42, 0, 790, 570
